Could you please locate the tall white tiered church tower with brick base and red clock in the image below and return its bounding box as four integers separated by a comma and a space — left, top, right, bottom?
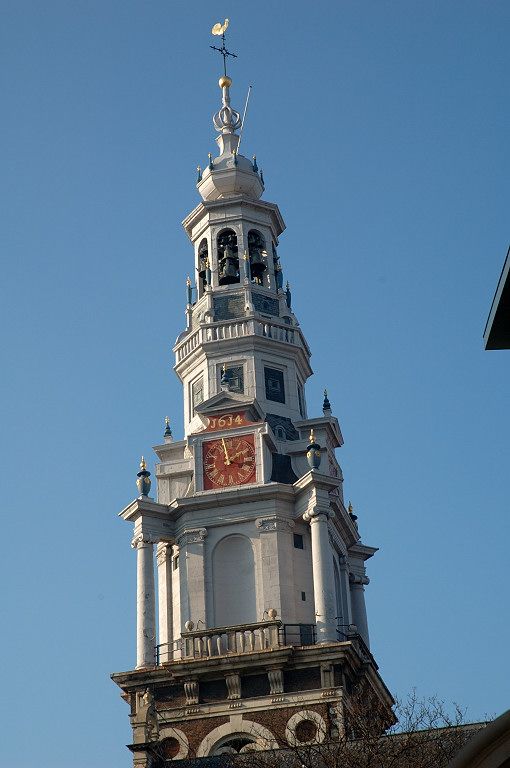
112, 46, 392, 768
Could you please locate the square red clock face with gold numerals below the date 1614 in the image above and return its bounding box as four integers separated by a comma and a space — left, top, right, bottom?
202, 435, 256, 491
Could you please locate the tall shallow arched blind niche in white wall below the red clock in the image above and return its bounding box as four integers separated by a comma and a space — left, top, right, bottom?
212, 534, 257, 627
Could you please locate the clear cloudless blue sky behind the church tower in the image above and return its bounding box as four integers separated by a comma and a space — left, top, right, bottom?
0, 0, 510, 768
